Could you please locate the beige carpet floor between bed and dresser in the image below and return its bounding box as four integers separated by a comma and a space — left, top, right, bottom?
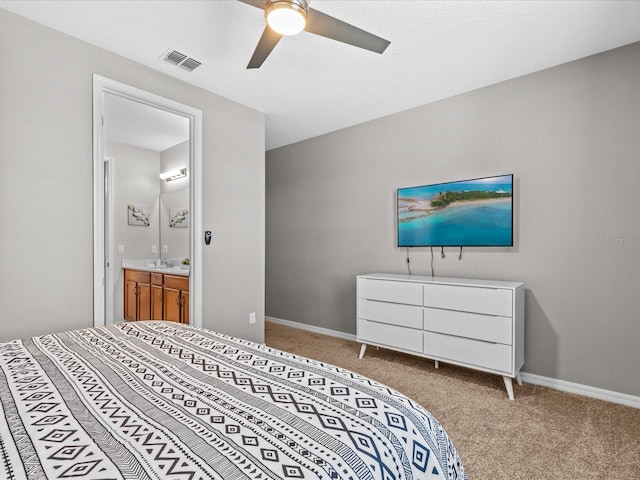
265, 322, 640, 480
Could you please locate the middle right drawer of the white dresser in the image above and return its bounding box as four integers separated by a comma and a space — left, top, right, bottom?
424, 308, 513, 345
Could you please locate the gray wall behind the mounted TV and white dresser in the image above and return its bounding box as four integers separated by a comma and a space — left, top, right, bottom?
266, 44, 640, 395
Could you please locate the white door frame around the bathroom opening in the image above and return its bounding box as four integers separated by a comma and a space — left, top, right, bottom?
93, 74, 202, 327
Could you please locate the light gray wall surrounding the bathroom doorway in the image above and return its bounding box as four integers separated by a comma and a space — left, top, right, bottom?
0, 9, 264, 341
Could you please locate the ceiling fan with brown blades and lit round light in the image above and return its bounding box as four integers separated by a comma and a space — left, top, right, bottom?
239, 0, 391, 68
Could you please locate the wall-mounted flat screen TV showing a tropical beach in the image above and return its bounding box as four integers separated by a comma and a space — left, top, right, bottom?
397, 175, 513, 247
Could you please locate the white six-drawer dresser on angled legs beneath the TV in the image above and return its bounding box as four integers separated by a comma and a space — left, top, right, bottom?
357, 273, 524, 400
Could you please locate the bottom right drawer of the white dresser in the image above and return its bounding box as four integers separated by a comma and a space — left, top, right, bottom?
424, 332, 512, 375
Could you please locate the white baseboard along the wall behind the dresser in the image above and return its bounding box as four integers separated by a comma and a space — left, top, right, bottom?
265, 317, 640, 408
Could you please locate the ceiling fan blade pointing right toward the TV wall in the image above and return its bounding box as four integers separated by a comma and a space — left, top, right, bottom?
304, 8, 391, 53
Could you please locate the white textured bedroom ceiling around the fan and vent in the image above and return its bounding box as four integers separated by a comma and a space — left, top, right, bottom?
0, 0, 640, 149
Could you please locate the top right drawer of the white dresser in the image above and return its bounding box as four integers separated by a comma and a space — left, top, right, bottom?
424, 284, 513, 317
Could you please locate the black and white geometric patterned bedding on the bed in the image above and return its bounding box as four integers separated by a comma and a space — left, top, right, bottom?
0, 321, 466, 480
